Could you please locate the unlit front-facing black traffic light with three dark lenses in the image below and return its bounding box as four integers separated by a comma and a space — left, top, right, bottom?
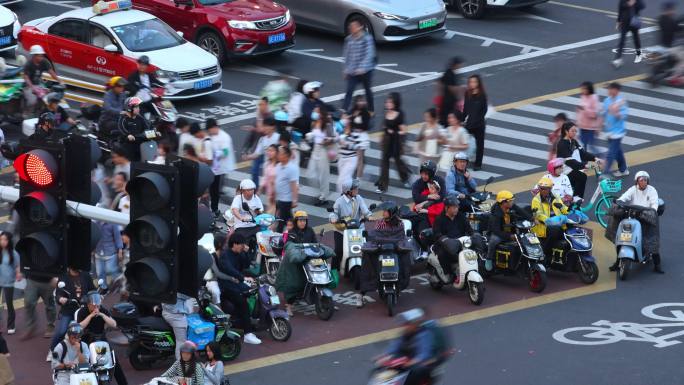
126, 162, 181, 303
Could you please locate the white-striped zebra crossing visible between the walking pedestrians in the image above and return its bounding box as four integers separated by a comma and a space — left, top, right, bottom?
224, 81, 684, 225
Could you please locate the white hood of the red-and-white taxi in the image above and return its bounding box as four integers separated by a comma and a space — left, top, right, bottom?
134, 42, 218, 72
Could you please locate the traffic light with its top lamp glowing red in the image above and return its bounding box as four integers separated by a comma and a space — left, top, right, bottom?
14, 139, 67, 277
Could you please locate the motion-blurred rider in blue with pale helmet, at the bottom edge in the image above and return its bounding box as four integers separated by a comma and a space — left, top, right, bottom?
377, 309, 451, 385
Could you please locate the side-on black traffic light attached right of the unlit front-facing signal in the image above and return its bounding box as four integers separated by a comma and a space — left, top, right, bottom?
171, 158, 214, 297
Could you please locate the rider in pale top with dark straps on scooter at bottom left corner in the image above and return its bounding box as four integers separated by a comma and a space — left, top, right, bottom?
52, 322, 90, 385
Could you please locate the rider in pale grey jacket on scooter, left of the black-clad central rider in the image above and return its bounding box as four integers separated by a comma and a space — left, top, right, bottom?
330, 179, 371, 270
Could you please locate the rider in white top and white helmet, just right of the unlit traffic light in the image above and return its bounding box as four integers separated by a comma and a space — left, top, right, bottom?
230, 179, 264, 247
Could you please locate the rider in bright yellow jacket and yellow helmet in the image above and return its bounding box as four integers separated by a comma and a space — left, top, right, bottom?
532, 177, 568, 256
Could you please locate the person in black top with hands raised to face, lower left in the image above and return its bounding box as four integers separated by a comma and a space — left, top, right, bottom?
74, 291, 128, 385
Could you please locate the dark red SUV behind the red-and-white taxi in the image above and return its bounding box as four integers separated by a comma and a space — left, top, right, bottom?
132, 0, 295, 62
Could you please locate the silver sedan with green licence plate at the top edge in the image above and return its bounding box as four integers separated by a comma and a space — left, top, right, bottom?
279, 0, 447, 41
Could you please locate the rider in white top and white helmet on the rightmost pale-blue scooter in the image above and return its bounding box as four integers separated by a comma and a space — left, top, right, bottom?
609, 170, 664, 274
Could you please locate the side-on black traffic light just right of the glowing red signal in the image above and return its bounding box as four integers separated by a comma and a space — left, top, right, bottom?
63, 135, 102, 271
